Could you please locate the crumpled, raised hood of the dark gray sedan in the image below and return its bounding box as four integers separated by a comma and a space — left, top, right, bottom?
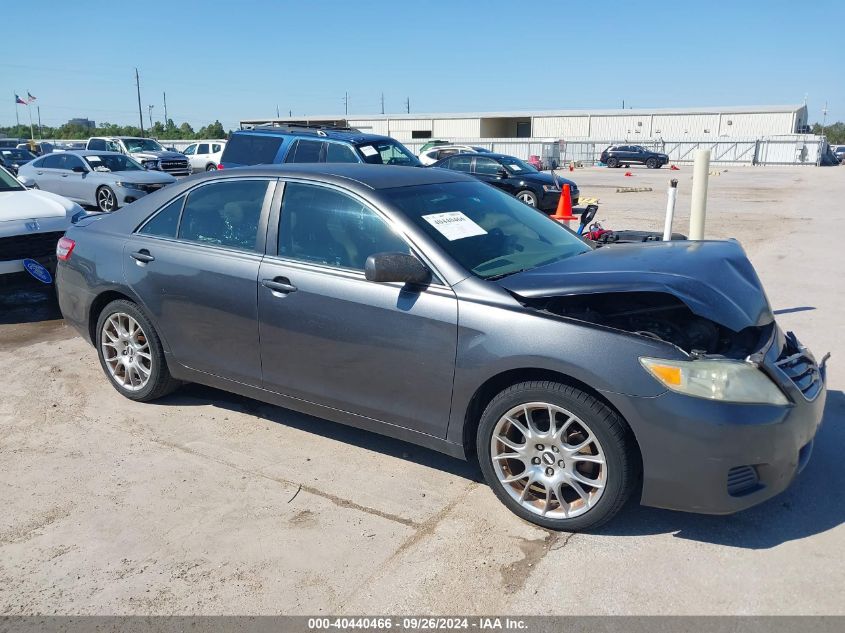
495, 241, 774, 332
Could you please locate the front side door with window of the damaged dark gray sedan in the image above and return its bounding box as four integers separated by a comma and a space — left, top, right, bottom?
258, 182, 457, 437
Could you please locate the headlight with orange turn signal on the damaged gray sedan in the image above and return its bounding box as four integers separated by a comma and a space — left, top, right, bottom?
640, 358, 789, 405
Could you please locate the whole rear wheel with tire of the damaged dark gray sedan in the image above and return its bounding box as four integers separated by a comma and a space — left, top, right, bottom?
95, 299, 179, 402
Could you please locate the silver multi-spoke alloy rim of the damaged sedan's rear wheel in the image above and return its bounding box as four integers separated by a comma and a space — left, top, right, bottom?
100, 312, 152, 391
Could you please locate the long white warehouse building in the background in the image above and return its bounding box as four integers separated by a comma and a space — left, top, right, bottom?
241, 104, 823, 164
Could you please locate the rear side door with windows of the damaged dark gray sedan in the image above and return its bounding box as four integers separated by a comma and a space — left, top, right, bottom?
123, 178, 275, 386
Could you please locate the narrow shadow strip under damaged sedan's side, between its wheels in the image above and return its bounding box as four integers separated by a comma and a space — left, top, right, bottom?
155, 384, 483, 482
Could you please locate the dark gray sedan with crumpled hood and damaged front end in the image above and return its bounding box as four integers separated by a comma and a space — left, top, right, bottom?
57, 164, 826, 530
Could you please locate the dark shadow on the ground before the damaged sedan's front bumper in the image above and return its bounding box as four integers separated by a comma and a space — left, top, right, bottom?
595, 391, 845, 549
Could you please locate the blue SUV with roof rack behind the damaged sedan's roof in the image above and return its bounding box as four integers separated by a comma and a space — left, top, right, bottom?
219, 126, 421, 169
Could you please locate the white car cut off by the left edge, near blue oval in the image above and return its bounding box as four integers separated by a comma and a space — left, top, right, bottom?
0, 168, 85, 281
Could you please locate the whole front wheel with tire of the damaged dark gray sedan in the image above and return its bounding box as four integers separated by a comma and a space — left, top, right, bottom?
476, 381, 639, 532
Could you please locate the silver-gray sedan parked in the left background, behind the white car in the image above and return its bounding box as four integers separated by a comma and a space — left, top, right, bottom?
18, 150, 176, 213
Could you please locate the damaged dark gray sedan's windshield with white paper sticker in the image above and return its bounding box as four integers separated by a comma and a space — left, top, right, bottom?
382, 182, 590, 279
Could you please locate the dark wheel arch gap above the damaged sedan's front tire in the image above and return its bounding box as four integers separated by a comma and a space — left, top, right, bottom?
461, 367, 642, 472
